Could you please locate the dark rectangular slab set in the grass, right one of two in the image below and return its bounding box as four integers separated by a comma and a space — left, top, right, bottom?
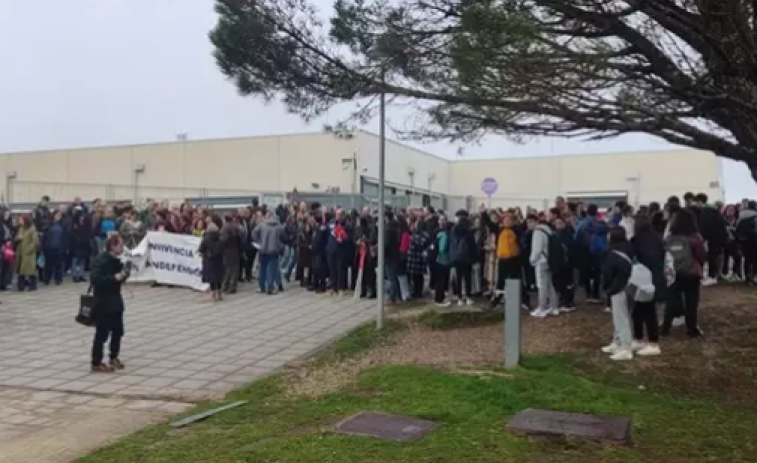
507, 409, 631, 444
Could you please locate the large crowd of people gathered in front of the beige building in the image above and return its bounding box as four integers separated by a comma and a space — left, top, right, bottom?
5, 193, 757, 368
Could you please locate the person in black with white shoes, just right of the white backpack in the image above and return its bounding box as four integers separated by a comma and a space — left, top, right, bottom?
631, 214, 668, 356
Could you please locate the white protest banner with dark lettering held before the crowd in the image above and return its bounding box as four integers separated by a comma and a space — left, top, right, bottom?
122, 232, 209, 291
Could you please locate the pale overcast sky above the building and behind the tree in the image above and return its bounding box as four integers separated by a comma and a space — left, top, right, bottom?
0, 0, 757, 200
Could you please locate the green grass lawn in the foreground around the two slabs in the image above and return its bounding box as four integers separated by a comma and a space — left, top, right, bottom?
81, 328, 757, 463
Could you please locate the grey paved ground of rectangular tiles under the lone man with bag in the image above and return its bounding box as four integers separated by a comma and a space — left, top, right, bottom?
0, 284, 375, 463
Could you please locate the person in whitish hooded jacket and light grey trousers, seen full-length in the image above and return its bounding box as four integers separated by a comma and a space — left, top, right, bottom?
529, 211, 560, 318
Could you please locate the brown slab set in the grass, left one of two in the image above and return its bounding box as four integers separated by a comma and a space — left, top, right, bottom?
336, 412, 436, 442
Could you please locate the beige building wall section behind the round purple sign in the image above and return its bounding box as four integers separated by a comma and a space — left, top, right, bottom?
449, 149, 724, 207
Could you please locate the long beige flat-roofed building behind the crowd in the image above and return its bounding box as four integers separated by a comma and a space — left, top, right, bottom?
0, 131, 724, 209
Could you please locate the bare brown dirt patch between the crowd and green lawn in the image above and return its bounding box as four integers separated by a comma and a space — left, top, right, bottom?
289, 286, 757, 401
